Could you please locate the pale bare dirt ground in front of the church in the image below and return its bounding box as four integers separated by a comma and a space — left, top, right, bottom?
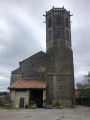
0, 106, 90, 120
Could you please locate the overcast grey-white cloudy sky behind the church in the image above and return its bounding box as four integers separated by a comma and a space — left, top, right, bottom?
0, 0, 90, 91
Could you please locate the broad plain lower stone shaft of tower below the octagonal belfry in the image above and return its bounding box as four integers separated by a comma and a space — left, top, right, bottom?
46, 46, 75, 106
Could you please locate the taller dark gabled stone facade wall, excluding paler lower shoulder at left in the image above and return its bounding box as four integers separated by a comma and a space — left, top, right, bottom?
20, 52, 46, 78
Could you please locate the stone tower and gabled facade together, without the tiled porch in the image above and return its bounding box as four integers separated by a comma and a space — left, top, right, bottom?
11, 7, 75, 107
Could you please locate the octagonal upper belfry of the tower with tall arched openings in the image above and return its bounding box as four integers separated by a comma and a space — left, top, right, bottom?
46, 7, 71, 52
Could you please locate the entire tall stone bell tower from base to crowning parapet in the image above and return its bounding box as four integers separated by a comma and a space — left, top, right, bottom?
46, 7, 75, 106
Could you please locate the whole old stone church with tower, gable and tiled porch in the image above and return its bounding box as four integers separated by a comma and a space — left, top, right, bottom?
8, 7, 75, 108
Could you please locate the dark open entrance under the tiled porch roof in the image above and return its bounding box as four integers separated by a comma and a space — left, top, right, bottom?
30, 90, 43, 108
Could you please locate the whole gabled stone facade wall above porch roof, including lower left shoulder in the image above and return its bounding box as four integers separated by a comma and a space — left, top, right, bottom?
11, 52, 46, 84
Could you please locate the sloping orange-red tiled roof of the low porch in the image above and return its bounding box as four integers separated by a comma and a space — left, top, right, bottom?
8, 80, 46, 89
